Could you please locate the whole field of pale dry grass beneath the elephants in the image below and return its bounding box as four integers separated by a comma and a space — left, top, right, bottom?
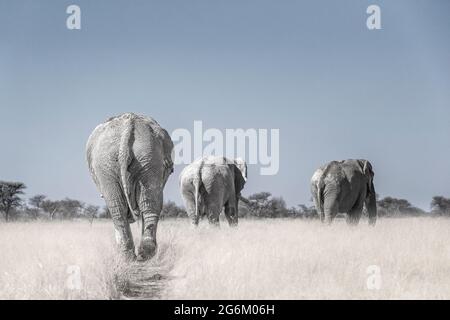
0, 218, 450, 299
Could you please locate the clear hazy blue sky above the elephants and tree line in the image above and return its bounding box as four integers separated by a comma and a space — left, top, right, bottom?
0, 0, 450, 209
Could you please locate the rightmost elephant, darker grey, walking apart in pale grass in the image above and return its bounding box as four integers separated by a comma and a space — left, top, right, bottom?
311, 159, 377, 225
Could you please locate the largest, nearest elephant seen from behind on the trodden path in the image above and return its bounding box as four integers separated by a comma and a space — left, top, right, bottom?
86, 113, 173, 260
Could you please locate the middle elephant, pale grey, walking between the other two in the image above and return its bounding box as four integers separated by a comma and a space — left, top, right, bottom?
180, 156, 247, 226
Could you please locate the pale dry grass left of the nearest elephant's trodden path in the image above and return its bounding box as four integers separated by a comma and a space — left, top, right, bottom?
0, 222, 117, 299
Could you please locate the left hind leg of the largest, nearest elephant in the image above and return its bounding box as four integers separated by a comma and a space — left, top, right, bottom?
103, 186, 136, 260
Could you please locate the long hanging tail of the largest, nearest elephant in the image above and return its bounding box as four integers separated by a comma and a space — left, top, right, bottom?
119, 118, 139, 221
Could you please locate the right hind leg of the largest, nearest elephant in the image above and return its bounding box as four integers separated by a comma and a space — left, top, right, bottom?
138, 190, 163, 261
